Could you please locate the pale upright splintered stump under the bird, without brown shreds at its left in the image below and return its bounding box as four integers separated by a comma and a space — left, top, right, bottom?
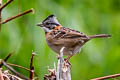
56, 47, 71, 80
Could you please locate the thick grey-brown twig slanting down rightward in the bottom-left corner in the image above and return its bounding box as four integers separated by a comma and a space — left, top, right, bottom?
2, 61, 29, 80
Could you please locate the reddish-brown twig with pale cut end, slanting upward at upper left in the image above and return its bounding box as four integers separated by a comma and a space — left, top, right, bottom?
0, 9, 34, 24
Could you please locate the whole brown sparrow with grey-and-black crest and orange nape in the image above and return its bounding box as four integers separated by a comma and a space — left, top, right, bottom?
37, 14, 111, 60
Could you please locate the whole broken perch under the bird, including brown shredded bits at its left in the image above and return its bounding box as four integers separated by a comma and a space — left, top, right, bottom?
44, 47, 71, 80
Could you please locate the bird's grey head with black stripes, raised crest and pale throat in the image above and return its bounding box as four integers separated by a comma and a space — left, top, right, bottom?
37, 15, 60, 32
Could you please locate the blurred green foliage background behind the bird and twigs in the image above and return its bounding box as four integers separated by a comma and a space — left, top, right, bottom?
0, 0, 120, 80
